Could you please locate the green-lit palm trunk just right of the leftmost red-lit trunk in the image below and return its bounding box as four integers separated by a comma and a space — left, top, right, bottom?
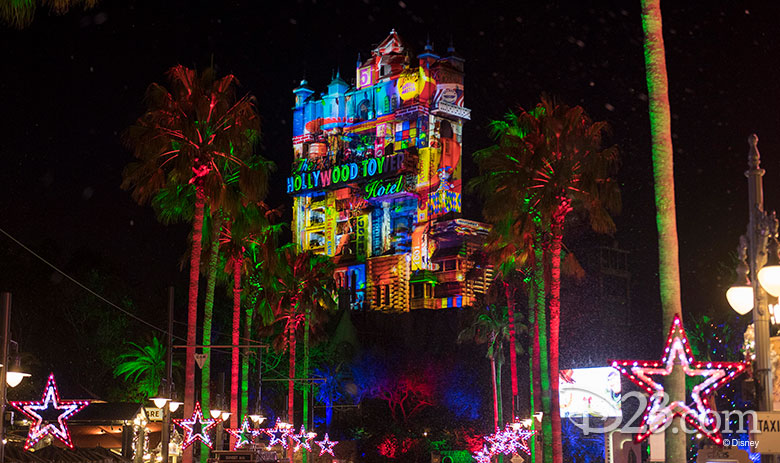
200, 211, 222, 463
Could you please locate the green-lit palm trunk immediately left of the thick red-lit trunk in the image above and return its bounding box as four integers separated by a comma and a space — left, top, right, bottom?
534, 243, 558, 463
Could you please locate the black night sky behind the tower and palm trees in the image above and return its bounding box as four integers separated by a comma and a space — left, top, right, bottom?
0, 0, 780, 374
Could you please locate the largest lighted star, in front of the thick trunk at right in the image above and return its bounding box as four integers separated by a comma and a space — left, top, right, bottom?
612, 315, 746, 445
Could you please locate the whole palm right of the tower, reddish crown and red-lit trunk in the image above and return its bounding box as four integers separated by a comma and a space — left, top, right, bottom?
475, 96, 620, 463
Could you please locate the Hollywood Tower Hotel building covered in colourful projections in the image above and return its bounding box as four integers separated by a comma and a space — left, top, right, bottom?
286, 31, 492, 311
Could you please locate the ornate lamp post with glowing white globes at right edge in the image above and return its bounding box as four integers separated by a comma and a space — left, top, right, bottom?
726, 134, 780, 462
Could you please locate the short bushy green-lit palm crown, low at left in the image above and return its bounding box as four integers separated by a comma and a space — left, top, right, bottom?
114, 337, 173, 401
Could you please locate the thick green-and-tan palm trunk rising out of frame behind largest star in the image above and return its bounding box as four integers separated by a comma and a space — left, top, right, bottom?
642, 0, 686, 463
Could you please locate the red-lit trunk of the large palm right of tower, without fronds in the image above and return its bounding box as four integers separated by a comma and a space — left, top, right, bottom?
550, 222, 563, 463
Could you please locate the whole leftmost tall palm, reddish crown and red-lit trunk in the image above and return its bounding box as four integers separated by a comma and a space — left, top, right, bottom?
122, 65, 267, 432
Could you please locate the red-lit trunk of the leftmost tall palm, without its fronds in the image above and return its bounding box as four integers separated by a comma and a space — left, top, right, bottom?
183, 188, 206, 463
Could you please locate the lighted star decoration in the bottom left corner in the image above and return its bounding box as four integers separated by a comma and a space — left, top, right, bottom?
9, 373, 89, 450
